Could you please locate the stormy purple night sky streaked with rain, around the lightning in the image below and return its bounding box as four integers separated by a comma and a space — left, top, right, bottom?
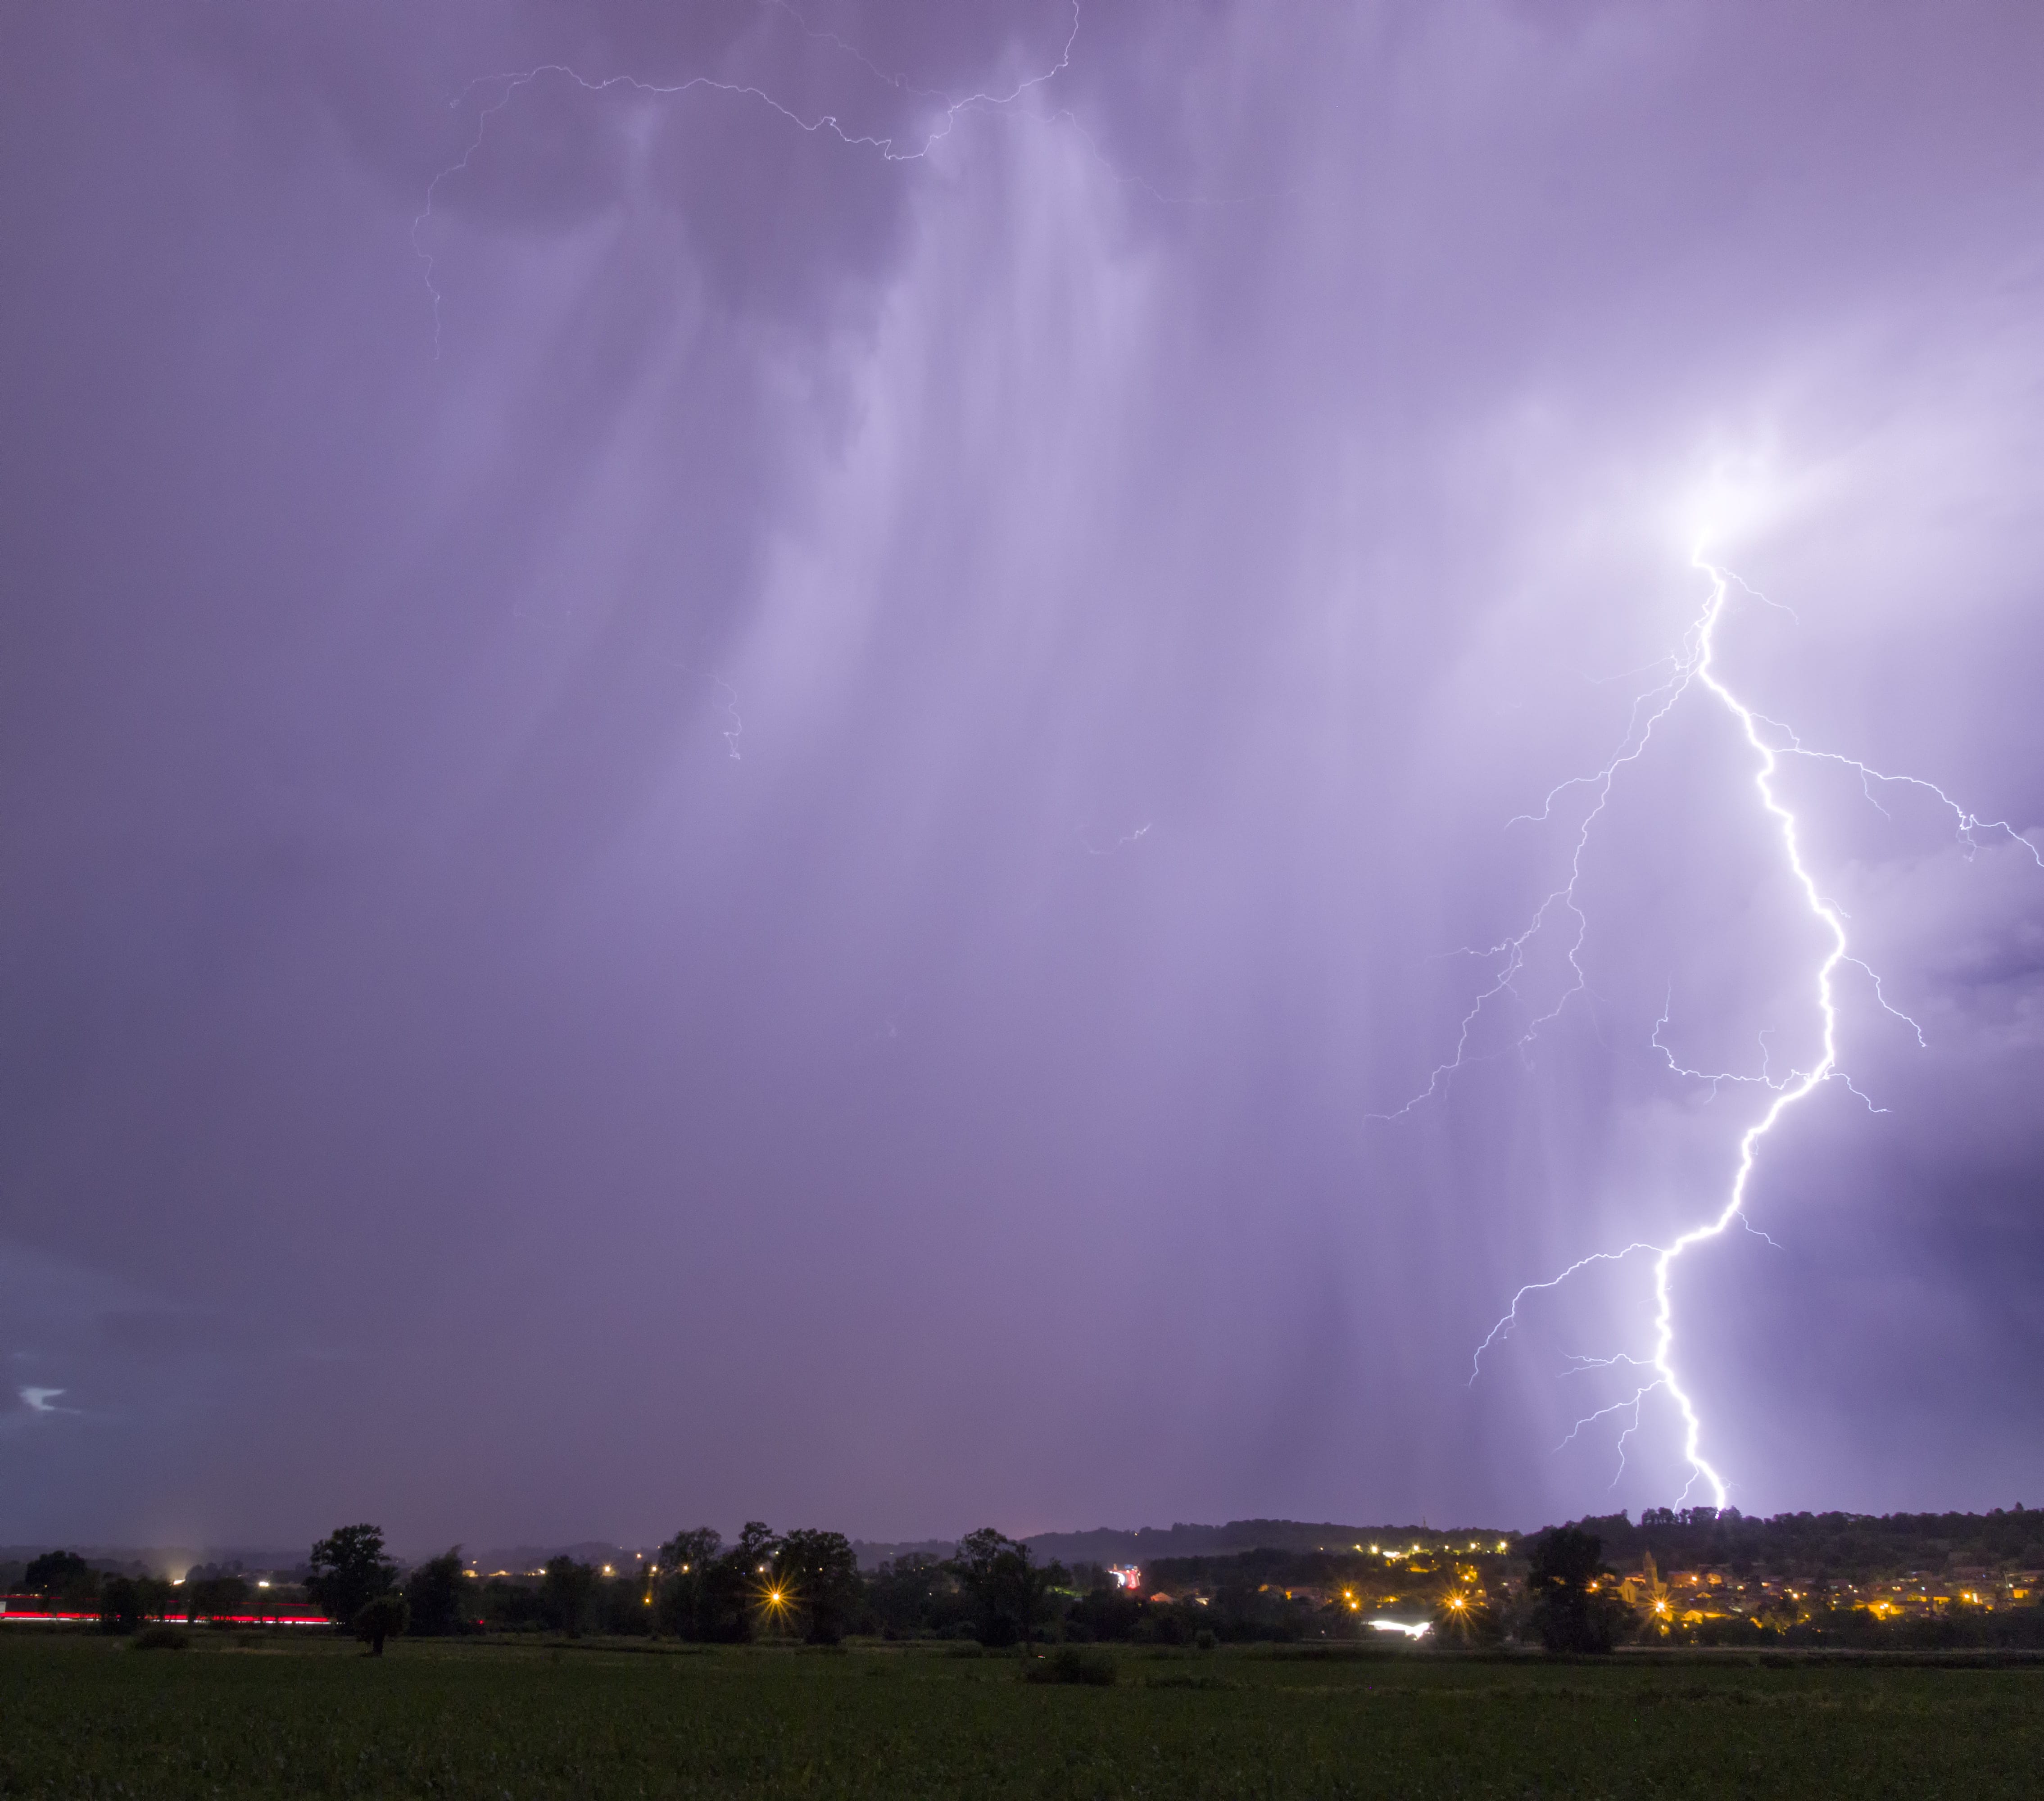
0, 0, 2044, 1550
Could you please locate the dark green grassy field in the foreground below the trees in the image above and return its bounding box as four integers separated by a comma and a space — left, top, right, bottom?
0, 1627, 2044, 1801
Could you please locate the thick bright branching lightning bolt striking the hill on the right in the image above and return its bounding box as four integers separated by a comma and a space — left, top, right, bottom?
1369, 548, 2044, 1507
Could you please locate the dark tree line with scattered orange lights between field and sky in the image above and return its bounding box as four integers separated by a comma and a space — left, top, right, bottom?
20, 1509, 2044, 1652
